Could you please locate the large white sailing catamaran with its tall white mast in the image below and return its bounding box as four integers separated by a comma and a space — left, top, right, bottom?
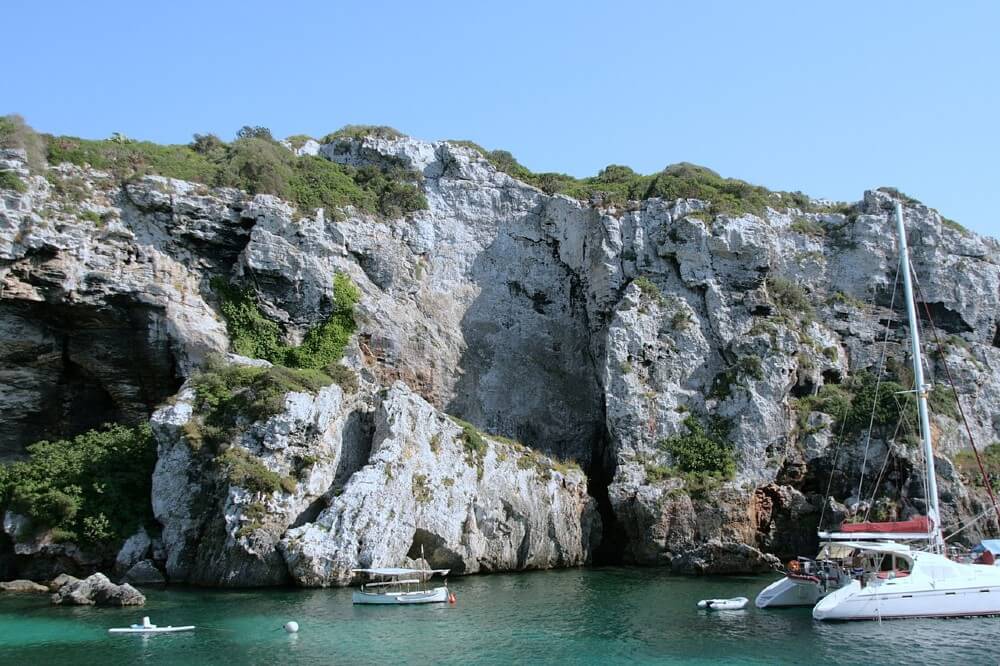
813, 203, 1000, 620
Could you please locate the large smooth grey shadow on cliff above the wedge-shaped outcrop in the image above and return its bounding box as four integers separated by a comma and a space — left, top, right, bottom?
446, 215, 604, 466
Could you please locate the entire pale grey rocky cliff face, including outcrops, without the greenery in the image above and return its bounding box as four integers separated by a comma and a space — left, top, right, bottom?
0, 137, 1000, 585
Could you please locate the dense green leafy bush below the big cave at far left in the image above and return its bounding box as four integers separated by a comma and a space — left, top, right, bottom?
0, 425, 156, 550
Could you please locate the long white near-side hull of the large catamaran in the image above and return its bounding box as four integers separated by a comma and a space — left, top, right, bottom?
813, 581, 1000, 621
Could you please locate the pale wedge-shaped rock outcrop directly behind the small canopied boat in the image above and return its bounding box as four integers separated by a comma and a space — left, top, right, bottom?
281, 383, 600, 586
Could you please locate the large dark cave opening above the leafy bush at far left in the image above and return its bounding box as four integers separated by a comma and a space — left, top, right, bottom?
0, 300, 182, 458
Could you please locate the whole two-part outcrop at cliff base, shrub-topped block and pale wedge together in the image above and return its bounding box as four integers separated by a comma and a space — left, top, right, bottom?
153, 370, 600, 587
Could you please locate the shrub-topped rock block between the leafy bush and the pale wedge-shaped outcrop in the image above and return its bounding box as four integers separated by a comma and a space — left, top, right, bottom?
146, 370, 368, 586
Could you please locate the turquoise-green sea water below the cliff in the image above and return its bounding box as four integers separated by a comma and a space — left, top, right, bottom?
0, 568, 1000, 666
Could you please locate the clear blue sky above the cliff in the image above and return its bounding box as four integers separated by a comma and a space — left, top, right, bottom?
7, 0, 1000, 236
